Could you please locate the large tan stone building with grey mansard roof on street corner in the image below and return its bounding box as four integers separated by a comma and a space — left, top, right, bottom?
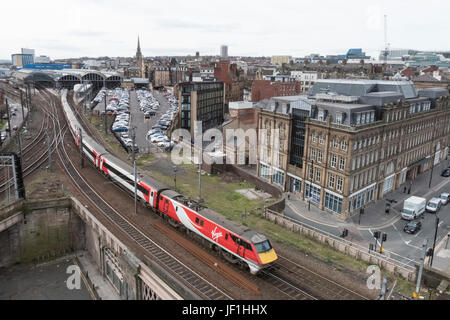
258, 80, 450, 219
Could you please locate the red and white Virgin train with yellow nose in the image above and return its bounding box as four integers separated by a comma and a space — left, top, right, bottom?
61, 90, 277, 274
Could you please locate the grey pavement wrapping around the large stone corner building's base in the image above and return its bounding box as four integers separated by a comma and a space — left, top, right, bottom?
286, 160, 450, 230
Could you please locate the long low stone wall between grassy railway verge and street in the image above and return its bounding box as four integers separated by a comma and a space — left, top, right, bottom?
263, 208, 416, 281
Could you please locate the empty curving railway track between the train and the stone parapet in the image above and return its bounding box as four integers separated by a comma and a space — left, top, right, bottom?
41, 89, 232, 300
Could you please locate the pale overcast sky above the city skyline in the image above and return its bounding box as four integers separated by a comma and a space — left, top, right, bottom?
0, 0, 450, 59
